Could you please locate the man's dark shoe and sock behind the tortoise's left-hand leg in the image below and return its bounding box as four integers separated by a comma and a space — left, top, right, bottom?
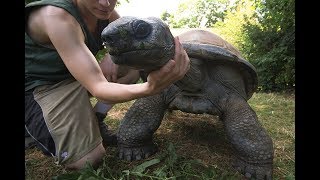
96, 112, 118, 147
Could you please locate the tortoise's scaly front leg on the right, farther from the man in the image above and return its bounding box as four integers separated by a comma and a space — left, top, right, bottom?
222, 95, 273, 179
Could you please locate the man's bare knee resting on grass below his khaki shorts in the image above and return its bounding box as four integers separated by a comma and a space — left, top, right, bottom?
65, 143, 106, 170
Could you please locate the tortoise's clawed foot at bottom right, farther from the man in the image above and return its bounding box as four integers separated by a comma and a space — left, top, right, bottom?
233, 159, 272, 180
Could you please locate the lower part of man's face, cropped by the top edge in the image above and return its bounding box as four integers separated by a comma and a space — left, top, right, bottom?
84, 0, 117, 20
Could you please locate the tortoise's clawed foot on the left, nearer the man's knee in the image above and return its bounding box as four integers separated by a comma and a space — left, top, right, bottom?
118, 143, 158, 161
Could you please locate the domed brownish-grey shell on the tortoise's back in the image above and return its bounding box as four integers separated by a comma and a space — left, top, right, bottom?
178, 29, 258, 99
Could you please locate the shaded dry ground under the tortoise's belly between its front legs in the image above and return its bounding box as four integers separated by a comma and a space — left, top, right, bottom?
154, 111, 236, 173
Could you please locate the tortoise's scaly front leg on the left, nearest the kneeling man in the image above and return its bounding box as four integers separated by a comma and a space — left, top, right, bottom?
118, 93, 167, 161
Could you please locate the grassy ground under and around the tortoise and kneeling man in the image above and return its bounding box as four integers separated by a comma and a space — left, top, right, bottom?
25, 93, 295, 180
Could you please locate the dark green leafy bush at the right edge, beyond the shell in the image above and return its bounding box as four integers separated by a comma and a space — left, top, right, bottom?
243, 0, 295, 91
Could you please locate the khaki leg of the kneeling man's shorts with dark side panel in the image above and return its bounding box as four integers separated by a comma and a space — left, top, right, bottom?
31, 79, 102, 164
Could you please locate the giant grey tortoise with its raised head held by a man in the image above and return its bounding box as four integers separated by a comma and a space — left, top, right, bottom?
101, 16, 273, 179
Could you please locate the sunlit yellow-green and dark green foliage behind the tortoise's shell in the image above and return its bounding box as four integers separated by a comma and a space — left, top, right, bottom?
214, 0, 295, 91
